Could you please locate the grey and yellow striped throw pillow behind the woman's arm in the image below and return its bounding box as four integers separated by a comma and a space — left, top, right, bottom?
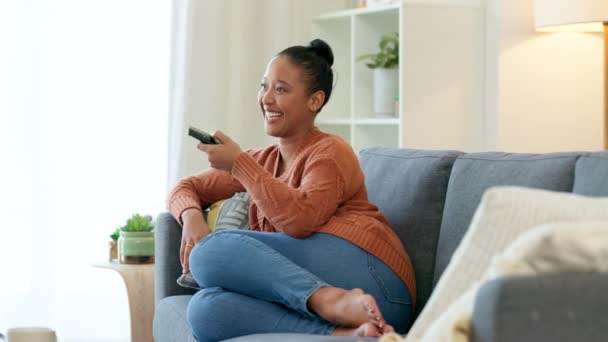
177, 192, 249, 290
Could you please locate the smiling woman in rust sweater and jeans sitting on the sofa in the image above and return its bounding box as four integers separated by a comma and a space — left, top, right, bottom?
168, 39, 415, 341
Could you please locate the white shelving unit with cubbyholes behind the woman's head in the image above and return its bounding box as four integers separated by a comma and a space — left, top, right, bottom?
310, 0, 486, 152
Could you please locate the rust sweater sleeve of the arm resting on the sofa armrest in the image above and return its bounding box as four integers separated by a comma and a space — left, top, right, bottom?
167, 169, 245, 225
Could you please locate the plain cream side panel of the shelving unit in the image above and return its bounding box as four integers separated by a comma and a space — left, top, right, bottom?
400, 0, 484, 152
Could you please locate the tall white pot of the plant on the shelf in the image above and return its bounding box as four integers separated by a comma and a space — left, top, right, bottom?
374, 68, 399, 117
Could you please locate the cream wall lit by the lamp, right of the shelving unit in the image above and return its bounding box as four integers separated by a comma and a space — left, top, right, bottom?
484, 0, 603, 153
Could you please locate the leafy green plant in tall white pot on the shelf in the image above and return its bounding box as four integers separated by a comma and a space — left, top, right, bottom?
357, 32, 399, 116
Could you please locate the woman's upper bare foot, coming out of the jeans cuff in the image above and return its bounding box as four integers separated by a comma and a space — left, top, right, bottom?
308, 287, 386, 331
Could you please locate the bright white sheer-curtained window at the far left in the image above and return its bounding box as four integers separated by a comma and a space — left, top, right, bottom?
0, 0, 172, 341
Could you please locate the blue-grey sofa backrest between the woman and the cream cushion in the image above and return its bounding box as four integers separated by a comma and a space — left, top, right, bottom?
360, 148, 608, 315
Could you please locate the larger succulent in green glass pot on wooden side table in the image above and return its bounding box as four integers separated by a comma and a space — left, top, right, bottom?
118, 214, 154, 264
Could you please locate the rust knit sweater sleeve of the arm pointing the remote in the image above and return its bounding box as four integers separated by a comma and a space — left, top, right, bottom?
232, 153, 344, 237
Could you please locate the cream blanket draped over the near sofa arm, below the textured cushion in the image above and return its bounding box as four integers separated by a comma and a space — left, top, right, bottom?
380, 221, 608, 342
